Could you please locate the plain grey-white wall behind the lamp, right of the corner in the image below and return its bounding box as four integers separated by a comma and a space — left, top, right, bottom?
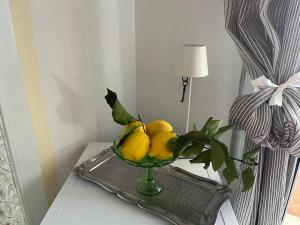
136, 0, 241, 144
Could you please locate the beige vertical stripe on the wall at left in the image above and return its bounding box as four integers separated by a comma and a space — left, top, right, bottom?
11, 0, 58, 202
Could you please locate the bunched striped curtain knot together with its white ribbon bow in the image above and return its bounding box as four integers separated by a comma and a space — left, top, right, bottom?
229, 72, 300, 155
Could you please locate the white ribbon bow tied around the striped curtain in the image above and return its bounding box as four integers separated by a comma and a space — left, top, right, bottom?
251, 72, 300, 107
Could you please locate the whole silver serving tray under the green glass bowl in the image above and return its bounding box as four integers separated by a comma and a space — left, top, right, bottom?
74, 149, 230, 225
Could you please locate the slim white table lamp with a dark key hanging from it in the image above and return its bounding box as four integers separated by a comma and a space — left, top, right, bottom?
176, 44, 208, 132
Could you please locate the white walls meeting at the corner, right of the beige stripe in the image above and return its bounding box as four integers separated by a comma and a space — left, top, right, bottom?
8, 0, 240, 195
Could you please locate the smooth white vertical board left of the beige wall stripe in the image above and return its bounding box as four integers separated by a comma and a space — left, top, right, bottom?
0, 0, 48, 225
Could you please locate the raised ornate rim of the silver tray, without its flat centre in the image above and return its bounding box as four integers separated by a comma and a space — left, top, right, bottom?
74, 148, 231, 225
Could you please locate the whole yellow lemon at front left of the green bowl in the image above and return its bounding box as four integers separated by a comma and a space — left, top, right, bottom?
121, 131, 150, 162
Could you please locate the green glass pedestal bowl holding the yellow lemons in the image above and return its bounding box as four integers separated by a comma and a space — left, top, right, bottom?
112, 145, 176, 196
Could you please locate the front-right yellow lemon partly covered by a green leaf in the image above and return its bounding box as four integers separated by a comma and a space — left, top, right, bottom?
148, 131, 176, 160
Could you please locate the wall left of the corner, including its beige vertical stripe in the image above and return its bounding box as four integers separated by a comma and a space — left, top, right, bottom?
11, 0, 136, 201
